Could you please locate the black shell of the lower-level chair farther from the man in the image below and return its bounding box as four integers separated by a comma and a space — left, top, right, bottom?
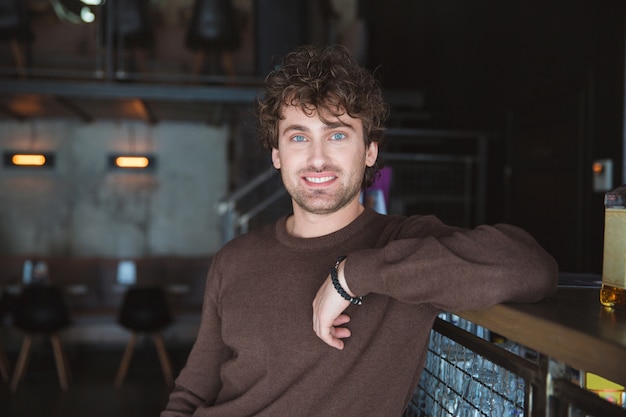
13, 285, 70, 333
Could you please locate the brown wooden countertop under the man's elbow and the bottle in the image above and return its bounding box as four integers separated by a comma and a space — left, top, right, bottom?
456, 287, 626, 385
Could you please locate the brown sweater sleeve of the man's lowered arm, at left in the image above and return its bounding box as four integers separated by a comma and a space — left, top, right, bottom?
161, 256, 231, 417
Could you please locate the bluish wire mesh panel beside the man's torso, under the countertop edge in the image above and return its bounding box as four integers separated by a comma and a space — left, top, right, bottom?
404, 316, 526, 417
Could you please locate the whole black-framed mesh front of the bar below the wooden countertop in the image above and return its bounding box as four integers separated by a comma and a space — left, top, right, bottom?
402, 313, 626, 417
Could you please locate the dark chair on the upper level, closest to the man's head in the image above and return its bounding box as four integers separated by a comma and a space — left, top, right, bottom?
185, 0, 240, 76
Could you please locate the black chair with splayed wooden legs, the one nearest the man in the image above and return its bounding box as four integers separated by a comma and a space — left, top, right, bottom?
115, 287, 174, 388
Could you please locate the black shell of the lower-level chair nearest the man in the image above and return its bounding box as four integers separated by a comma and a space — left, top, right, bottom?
118, 286, 172, 332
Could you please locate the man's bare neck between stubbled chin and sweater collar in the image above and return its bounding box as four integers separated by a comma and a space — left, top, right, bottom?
287, 198, 365, 238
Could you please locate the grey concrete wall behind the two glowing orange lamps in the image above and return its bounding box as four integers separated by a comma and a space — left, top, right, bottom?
0, 120, 228, 257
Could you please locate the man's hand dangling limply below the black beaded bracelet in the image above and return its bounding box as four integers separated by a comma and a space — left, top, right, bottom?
313, 262, 350, 350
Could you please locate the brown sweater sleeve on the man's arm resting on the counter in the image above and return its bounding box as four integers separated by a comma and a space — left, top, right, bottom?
345, 216, 558, 311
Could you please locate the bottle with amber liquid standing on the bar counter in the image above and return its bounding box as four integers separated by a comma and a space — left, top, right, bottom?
600, 185, 626, 309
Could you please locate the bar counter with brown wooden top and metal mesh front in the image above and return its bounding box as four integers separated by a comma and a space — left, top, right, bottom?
403, 287, 626, 417
